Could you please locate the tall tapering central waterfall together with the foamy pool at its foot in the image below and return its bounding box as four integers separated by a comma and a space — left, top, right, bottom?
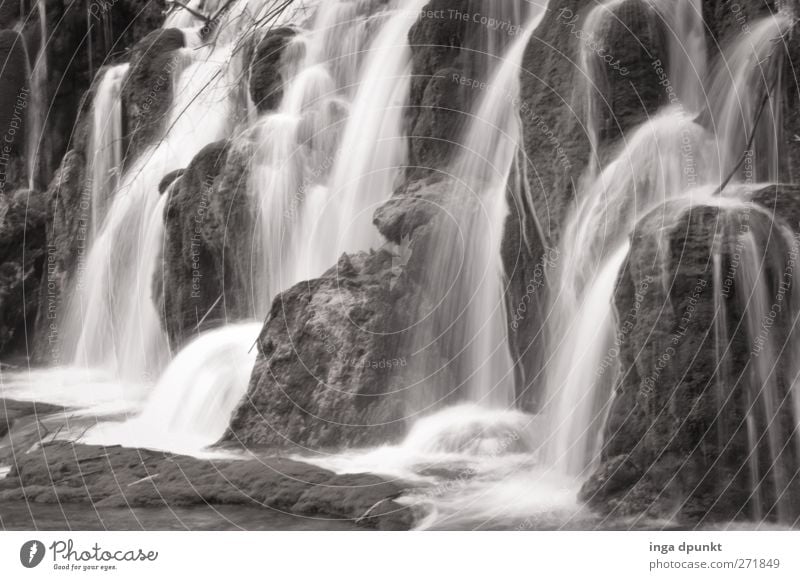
296, 6, 585, 528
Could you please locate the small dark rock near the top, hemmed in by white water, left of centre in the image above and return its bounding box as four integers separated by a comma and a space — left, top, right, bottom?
250, 27, 297, 113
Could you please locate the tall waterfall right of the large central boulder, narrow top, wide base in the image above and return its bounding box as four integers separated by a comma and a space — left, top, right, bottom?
412, 14, 539, 412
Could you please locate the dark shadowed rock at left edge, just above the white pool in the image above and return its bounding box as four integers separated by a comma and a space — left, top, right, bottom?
0, 190, 47, 357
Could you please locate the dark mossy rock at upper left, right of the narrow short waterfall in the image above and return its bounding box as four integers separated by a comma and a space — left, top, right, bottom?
122, 28, 185, 159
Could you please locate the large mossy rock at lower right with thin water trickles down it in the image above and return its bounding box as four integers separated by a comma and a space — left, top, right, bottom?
581, 186, 800, 521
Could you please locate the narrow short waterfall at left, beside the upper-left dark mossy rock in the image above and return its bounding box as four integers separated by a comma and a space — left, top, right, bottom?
86, 63, 130, 238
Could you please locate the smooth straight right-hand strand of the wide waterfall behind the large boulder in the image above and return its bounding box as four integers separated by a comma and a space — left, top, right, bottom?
310, 0, 426, 266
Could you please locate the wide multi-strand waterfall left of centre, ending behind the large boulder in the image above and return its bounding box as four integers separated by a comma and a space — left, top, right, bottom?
249, 0, 425, 308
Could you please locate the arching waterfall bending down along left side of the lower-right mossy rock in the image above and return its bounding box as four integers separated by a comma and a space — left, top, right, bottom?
545, 108, 714, 475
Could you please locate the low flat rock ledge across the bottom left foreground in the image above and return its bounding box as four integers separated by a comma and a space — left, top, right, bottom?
0, 442, 413, 529
